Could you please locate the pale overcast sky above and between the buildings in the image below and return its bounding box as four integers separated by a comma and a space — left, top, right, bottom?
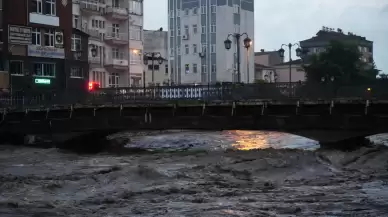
144, 0, 388, 73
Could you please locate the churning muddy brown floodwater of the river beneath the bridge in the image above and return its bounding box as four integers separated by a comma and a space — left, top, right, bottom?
0, 131, 388, 217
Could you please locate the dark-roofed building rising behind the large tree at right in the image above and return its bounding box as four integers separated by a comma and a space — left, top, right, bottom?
300, 26, 373, 63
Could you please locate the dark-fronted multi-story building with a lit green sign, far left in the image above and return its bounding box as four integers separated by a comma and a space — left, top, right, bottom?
0, 0, 89, 96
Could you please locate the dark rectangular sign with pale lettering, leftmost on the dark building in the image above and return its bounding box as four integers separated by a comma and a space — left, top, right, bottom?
8, 25, 32, 45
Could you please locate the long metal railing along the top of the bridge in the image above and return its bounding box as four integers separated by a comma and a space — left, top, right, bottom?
0, 83, 388, 108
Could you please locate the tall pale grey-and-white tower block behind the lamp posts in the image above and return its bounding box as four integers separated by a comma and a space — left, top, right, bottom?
168, 0, 254, 84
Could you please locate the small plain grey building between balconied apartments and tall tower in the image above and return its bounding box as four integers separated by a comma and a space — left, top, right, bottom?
143, 30, 170, 86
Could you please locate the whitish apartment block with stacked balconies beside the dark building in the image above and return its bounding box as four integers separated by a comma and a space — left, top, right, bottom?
73, 0, 143, 88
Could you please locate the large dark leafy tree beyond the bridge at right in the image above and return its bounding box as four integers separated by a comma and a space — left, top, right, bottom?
304, 41, 379, 84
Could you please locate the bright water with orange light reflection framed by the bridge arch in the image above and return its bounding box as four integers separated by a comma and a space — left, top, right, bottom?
127, 130, 318, 150
